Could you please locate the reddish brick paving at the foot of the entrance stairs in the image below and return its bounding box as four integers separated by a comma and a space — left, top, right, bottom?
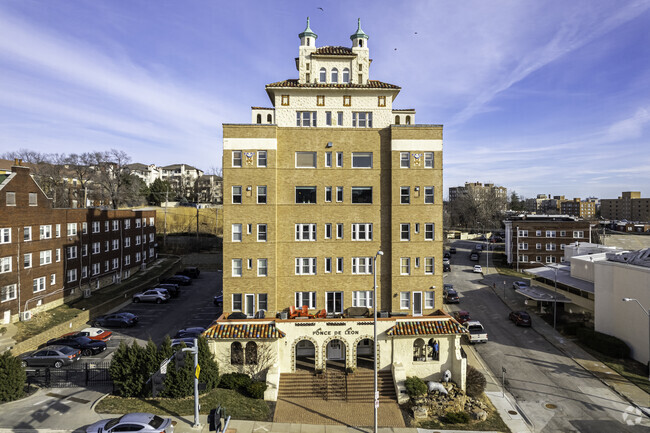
273, 398, 405, 427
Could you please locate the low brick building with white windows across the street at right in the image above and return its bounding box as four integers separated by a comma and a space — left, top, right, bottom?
504, 215, 591, 269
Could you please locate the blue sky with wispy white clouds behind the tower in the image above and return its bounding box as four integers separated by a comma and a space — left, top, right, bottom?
0, 0, 650, 198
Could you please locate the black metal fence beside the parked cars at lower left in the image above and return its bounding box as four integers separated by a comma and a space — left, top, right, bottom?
27, 362, 113, 388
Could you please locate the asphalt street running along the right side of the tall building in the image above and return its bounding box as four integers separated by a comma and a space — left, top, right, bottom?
444, 241, 650, 433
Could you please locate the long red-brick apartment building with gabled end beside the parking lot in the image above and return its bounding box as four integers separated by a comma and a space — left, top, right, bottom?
0, 162, 156, 323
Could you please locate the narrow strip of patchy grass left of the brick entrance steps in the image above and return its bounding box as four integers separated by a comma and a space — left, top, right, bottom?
95, 388, 273, 421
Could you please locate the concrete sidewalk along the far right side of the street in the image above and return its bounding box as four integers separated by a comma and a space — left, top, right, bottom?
483, 267, 650, 416
